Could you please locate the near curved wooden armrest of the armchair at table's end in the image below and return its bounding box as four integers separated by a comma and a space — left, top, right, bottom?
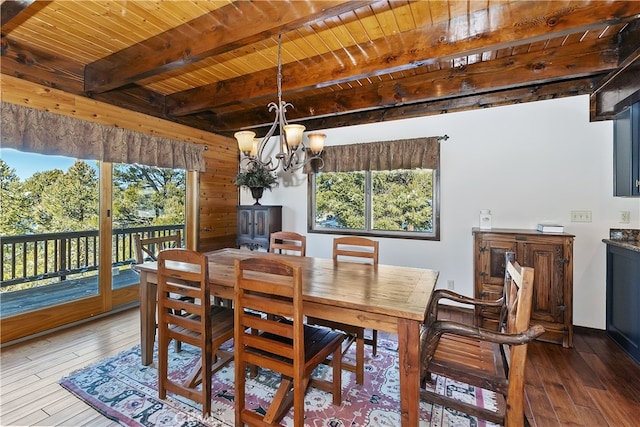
420, 320, 545, 366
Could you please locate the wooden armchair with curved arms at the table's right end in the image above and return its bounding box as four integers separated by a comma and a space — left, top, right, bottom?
420, 255, 544, 427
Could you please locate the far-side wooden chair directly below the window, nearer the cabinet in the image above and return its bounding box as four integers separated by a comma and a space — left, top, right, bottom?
307, 236, 379, 384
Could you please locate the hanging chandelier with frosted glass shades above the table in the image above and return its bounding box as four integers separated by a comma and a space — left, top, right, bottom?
233, 34, 326, 172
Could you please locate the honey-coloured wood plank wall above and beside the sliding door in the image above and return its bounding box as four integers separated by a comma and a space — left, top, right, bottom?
0, 74, 239, 251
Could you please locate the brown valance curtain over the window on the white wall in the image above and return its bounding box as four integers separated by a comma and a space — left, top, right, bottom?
307, 136, 440, 173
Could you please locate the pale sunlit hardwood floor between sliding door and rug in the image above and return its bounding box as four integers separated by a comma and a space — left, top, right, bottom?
0, 308, 140, 426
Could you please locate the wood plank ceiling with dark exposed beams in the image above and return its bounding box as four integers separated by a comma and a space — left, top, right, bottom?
0, 0, 640, 139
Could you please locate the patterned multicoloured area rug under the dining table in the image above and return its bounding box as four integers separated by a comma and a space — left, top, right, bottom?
60, 340, 495, 427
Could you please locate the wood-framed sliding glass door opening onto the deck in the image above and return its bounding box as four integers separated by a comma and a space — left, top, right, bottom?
0, 149, 186, 343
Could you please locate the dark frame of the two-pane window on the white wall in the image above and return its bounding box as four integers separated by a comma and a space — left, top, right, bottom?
307, 167, 440, 241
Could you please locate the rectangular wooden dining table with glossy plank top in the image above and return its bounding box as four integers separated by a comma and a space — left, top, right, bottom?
136, 249, 438, 426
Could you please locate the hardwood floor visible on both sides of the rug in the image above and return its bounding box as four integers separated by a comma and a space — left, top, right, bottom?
0, 308, 640, 427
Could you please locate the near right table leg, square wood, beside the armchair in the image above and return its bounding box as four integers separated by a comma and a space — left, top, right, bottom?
398, 319, 420, 427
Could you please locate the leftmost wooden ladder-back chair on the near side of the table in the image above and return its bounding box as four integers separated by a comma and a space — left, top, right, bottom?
158, 249, 234, 416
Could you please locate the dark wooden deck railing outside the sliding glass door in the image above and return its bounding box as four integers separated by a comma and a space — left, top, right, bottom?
0, 224, 184, 290
